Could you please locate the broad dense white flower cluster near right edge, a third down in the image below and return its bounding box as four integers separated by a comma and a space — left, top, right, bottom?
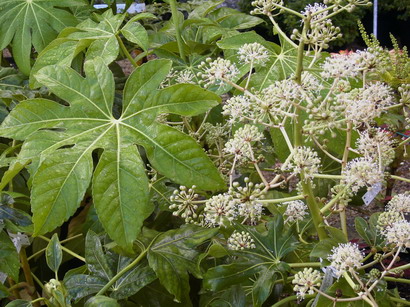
336, 82, 394, 125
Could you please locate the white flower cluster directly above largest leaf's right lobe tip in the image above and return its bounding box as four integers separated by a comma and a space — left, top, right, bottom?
197, 58, 239, 87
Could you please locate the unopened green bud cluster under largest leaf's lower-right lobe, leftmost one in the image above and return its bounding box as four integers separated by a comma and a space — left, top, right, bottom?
169, 186, 198, 223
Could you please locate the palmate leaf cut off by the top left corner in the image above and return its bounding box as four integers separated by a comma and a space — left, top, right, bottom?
0, 0, 84, 75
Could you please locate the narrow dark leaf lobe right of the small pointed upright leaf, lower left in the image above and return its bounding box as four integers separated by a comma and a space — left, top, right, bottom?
85, 230, 114, 282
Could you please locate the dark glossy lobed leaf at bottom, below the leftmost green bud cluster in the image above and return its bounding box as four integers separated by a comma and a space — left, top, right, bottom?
148, 225, 218, 302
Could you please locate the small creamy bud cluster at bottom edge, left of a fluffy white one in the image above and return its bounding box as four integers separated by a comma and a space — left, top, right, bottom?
292, 268, 322, 299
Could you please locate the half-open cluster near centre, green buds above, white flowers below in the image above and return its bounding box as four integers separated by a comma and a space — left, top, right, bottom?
228, 177, 266, 224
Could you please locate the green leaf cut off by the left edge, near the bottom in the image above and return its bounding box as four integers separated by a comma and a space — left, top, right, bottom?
0, 231, 20, 282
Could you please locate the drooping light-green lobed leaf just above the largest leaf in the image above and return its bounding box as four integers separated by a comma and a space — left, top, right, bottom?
30, 10, 155, 86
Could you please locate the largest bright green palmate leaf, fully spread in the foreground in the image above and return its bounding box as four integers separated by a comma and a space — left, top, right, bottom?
0, 58, 224, 253
